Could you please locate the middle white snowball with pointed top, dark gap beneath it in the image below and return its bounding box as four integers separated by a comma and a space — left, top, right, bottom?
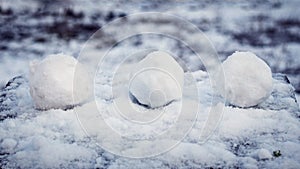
129, 51, 184, 108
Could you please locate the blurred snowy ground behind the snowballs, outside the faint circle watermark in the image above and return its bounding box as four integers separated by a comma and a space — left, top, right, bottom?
0, 0, 300, 96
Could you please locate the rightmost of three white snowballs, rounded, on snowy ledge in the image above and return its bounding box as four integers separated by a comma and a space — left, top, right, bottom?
221, 52, 273, 107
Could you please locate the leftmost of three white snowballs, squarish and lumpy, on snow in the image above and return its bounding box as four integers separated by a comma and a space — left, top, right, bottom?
29, 54, 91, 110
